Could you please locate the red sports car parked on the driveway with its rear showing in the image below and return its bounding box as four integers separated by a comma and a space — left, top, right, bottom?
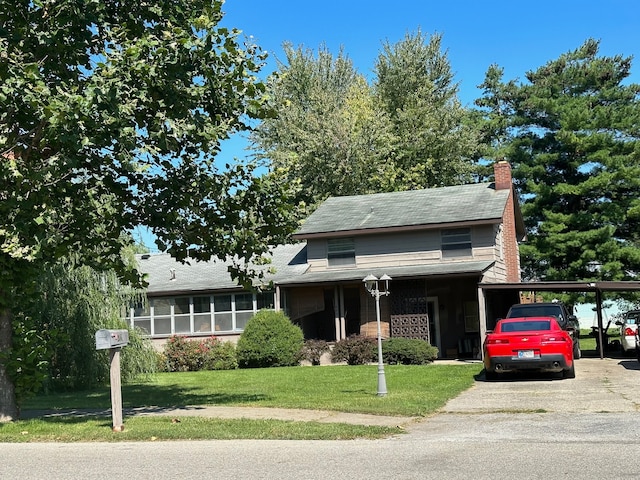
484, 317, 576, 380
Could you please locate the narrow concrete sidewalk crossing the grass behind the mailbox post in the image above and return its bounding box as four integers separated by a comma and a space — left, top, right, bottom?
20, 405, 421, 428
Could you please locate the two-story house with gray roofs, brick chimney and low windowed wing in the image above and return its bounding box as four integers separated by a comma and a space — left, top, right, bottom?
130, 162, 524, 356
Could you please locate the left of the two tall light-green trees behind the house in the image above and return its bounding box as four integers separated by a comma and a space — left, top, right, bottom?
252, 44, 389, 207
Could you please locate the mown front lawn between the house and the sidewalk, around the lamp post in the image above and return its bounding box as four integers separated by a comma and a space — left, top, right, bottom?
23, 364, 482, 416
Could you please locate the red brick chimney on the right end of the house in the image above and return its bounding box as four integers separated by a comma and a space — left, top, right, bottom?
493, 160, 520, 283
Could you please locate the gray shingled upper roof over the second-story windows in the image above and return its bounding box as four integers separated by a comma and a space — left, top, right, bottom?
295, 183, 509, 238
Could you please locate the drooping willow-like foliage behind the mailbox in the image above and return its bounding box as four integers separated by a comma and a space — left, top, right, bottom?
15, 262, 156, 390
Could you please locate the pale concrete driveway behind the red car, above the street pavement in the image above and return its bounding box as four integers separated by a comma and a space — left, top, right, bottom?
442, 358, 640, 413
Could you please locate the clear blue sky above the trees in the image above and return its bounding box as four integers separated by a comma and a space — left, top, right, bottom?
132, 0, 640, 251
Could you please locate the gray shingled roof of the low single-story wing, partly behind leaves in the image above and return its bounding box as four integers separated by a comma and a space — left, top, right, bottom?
137, 243, 308, 296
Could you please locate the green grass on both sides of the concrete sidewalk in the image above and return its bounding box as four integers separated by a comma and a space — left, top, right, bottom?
5, 364, 482, 442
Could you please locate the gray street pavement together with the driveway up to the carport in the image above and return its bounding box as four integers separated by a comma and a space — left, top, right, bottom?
0, 359, 640, 480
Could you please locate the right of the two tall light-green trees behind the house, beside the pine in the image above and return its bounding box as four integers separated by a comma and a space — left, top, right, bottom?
374, 30, 479, 190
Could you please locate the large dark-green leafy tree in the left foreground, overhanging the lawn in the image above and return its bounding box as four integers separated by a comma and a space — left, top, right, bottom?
0, 0, 294, 420
